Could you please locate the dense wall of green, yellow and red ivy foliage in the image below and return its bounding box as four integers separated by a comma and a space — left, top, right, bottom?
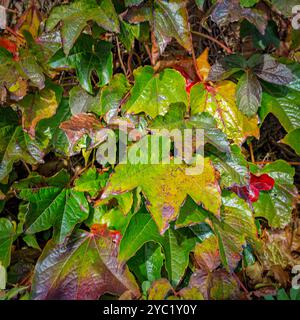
0, 0, 300, 300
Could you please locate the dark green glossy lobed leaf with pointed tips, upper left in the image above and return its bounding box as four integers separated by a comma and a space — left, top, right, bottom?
49, 34, 113, 94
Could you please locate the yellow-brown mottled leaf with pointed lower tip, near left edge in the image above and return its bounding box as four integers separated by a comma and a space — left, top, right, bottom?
18, 88, 59, 137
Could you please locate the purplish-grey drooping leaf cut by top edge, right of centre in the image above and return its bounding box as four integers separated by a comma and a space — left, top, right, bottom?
211, 0, 267, 34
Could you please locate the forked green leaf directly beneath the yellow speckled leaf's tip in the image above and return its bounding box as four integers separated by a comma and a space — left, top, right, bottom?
119, 212, 195, 286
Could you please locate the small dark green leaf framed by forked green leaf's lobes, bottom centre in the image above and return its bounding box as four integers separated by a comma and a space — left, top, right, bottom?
127, 242, 164, 283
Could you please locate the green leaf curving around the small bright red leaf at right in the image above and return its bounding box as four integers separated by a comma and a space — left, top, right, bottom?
251, 160, 297, 228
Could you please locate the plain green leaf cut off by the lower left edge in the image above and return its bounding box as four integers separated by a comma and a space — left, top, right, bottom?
0, 218, 15, 267
